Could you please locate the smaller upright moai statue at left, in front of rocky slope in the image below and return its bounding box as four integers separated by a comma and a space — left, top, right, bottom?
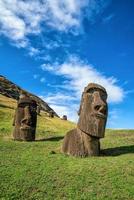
13, 92, 37, 141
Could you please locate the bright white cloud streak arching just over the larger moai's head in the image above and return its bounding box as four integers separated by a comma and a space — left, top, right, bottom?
41, 57, 125, 103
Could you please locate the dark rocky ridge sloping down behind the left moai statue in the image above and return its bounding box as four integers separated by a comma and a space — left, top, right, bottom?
0, 75, 58, 117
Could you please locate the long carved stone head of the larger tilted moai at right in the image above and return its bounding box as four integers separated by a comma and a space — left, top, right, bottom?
78, 83, 108, 138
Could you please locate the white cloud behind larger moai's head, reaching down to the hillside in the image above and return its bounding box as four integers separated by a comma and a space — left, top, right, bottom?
41, 56, 125, 121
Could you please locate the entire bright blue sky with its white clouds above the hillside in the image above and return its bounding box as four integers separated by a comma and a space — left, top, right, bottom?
0, 0, 134, 128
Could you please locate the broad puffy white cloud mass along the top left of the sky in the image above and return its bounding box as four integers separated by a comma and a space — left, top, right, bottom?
0, 0, 109, 47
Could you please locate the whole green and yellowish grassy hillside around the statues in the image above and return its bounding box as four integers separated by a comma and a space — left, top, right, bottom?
0, 95, 134, 200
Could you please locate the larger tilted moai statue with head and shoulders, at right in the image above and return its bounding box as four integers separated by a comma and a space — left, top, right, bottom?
62, 83, 108, 157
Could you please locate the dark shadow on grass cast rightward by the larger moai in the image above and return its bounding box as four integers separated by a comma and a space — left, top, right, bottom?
101, 145, 134, 156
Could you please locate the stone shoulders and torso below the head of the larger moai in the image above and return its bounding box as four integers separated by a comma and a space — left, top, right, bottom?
62, 128, 100, 157
